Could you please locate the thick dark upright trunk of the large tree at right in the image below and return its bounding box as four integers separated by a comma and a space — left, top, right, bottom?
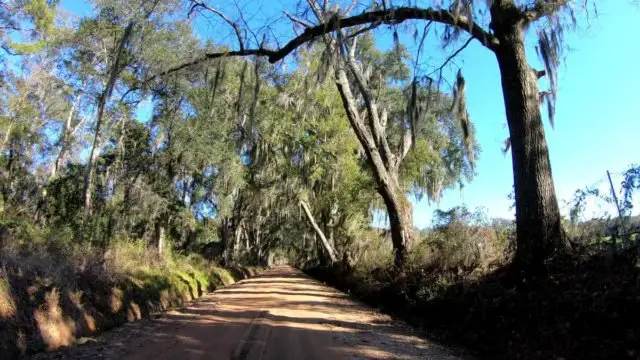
494, 19, 565, 272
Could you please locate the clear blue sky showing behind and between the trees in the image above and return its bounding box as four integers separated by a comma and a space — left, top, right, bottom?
63, 0, 640, 228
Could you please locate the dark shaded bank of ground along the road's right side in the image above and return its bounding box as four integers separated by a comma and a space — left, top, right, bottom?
308, 250, 640, 360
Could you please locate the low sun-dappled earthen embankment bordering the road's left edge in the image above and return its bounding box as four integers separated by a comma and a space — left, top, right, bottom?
0, 264, 254, 359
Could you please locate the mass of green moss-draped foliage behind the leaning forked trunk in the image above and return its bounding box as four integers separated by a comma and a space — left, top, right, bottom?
0, 0, 480, 278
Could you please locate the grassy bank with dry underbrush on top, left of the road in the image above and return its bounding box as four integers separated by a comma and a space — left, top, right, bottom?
0, 241, 256, 359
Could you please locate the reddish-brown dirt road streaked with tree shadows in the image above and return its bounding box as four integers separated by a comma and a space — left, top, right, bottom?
36, 266, 456, 360
